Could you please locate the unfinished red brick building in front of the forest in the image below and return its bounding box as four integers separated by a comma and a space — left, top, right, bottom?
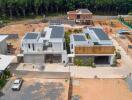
67, 9, 92, 24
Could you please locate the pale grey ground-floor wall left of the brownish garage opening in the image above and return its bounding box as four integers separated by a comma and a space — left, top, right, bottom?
24, 54, 44, 64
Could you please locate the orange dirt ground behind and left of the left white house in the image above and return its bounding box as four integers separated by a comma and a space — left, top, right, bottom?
0, 22, 48, 54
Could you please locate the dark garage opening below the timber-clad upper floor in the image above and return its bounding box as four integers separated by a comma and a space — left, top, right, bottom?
94, 56, 110, 64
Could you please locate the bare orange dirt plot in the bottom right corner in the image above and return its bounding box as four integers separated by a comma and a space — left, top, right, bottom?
72, 79, 132, 100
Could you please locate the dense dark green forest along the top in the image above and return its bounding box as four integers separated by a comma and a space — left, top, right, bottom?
0, 0, 132, 18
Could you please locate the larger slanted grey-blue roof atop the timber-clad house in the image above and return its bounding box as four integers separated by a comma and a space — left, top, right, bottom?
89, 28, 110, 40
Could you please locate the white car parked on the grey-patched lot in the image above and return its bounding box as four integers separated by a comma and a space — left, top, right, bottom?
12, 78, 23, 91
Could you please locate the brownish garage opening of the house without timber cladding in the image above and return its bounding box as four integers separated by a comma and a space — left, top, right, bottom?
45, 54, 62, 63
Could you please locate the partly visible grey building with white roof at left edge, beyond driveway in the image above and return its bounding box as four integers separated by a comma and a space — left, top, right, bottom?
0, 35, 8, 54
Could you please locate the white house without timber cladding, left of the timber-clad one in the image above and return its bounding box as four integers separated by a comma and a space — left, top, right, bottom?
21, 26, 67, 64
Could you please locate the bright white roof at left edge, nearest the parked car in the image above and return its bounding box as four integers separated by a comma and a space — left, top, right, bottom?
0, 54, 15, 71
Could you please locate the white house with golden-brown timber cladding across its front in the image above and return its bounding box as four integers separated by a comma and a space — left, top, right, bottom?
68, 27, 115, 65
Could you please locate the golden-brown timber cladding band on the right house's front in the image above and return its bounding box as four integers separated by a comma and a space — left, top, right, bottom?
75, 46, 115, 54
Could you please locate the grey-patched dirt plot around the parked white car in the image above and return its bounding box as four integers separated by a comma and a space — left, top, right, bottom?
0, 78, 69, 100
